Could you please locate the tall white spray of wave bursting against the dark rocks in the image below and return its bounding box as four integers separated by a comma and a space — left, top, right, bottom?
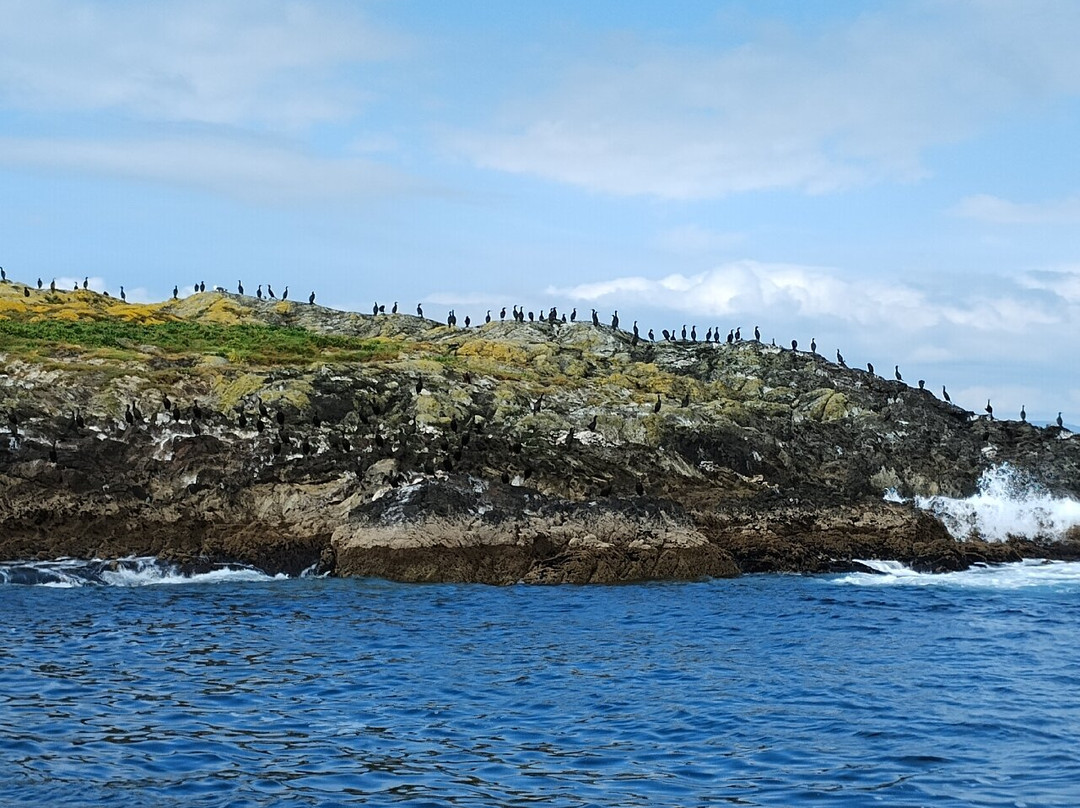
886, 463, 1080, 541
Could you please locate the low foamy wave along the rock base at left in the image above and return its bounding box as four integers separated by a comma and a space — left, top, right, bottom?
0, 556, 295, 589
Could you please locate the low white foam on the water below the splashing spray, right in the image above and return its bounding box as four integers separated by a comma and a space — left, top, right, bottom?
831, 558, 1080, 590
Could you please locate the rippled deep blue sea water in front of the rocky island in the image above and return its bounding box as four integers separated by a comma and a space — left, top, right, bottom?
0, 565, 1080, 806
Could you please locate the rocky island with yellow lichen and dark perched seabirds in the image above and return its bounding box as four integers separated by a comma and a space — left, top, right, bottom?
0, 283, 1080, 583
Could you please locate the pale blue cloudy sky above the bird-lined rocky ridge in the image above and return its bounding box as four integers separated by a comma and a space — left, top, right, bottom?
0, 0, 1080, 423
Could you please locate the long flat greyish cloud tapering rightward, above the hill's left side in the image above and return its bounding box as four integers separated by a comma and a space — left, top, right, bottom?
0, 137, 419, 203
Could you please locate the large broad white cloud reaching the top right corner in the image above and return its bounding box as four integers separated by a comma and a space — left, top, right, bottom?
456, 0, 1080, 199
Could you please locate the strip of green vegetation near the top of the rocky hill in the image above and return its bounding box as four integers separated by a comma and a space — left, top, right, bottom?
0, 319, 402, 364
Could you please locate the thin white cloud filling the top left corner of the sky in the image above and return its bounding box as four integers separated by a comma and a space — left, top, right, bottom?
0, 0, 405, 130
